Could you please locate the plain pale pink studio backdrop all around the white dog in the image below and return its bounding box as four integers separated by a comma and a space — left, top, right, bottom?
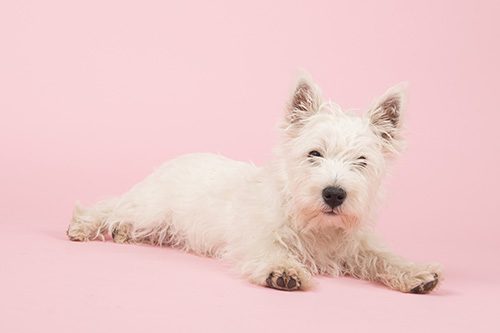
0, 0, 500, 332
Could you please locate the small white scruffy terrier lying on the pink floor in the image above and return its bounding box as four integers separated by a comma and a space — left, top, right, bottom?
67, 78, 440, 293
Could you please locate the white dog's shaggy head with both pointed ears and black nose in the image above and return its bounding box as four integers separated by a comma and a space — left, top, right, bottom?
279, 78, 405, 229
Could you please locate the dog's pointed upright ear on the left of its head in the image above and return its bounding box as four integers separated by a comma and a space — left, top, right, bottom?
286, 76, 321, 125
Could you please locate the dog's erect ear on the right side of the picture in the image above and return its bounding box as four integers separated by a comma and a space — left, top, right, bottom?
368, 83, 406, 153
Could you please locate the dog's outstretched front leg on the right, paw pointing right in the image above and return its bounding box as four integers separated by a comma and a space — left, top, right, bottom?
344, 233, 441, 294
